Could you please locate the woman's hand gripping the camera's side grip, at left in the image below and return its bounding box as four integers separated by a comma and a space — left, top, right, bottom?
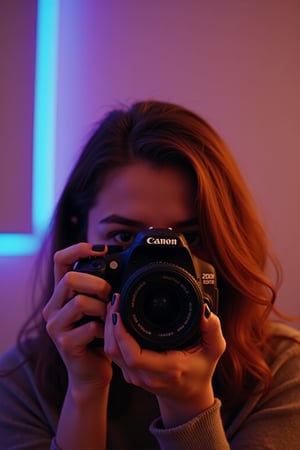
43, 243, 112, 392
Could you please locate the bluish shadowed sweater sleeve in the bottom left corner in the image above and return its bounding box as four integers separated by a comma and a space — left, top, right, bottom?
0, 348, 56, 450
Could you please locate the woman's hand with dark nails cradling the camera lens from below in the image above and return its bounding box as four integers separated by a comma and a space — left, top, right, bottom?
104, 295, 226, 427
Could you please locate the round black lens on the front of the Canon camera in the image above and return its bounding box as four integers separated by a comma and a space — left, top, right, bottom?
120, 262, 203, 351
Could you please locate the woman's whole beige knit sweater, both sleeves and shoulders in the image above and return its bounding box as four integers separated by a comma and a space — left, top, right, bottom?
0, 324, 300, 450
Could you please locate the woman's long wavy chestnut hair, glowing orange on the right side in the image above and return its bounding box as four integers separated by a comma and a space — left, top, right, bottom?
18, 101, 279, 407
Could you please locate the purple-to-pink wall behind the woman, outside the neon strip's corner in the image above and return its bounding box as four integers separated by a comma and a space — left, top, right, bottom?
0, 0, 300, 356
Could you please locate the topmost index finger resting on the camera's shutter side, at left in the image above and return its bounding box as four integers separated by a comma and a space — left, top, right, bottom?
54, 242, 107, 284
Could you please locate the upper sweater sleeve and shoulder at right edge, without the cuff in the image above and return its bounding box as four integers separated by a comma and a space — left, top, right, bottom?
226, 327, 300, 450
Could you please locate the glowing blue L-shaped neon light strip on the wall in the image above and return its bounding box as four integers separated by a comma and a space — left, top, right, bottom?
0, 0, 59, 256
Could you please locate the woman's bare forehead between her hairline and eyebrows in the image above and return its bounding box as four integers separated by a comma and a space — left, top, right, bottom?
93, 162, 195, 226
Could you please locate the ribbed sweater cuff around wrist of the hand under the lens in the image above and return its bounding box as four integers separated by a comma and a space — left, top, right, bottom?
150, 399, 230, 450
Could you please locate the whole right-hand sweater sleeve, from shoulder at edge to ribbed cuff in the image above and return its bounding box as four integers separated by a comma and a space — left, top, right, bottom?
150, 326, 300, 450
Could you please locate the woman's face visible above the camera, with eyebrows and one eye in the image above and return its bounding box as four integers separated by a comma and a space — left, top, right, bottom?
88, 162, 199, 248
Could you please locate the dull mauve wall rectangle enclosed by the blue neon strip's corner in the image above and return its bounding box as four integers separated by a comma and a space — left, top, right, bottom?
0, 0, 36, 233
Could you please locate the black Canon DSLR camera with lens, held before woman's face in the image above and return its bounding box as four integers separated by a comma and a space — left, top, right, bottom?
74, 228, 218, 351
